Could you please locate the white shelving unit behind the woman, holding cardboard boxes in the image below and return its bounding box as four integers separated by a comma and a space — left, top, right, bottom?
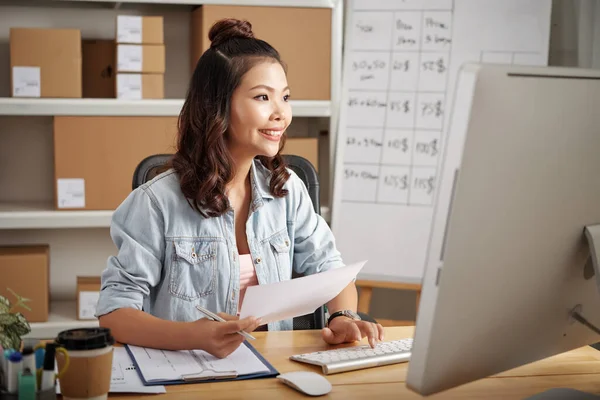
0, 0, 343, 339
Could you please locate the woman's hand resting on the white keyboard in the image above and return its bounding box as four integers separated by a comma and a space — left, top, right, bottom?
322, 316, 383, 347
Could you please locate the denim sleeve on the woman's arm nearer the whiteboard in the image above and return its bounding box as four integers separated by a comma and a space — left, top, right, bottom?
290, 173, 344, 275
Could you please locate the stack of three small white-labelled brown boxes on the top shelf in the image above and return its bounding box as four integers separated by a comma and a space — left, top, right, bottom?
115, 15, 165, 99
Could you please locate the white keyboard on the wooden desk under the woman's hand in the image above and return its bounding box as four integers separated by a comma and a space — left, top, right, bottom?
290, 338, 413, 375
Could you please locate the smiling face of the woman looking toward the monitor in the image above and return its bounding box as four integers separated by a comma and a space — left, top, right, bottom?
227, 61, 292, 160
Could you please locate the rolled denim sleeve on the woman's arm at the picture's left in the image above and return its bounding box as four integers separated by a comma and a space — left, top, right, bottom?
96, 186, 165, 317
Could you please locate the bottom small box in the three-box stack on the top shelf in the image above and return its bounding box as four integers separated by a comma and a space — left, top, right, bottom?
116, 73, 165, 100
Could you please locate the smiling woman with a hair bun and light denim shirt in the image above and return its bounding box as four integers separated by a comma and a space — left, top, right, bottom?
97, 19, 383, 357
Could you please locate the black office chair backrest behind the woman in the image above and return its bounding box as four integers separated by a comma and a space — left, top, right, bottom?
132, 154, 325, 330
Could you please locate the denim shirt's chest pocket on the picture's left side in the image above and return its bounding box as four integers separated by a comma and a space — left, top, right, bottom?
169, 240, 217, 301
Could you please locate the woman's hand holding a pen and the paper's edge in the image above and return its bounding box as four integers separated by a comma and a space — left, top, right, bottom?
194, 315, 260, 358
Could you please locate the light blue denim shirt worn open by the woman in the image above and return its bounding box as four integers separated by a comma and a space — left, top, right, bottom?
96, 160, 343, 330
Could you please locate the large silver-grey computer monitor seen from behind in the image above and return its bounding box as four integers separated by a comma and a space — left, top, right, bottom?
406, 64, 600, 395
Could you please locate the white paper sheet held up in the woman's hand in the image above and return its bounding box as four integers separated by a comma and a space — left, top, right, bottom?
240, 261, 366, 323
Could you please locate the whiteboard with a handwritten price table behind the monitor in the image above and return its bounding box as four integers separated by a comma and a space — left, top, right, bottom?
331, 0, 551, 283
